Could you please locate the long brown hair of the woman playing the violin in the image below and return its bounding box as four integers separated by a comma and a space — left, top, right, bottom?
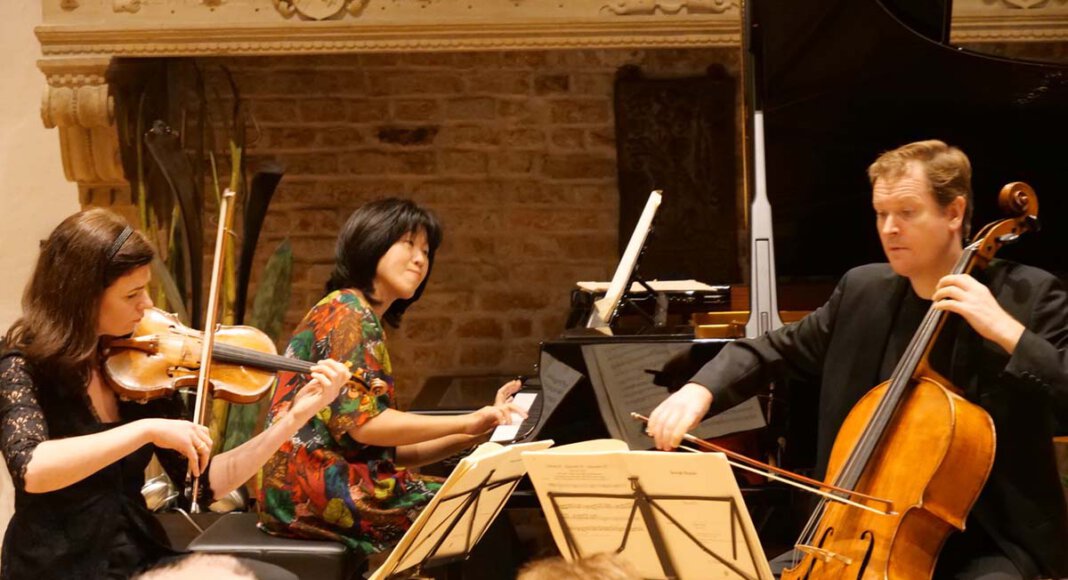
4, 208, 154, 388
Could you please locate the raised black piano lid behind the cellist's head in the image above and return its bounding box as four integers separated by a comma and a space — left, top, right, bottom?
750, 0, 1068, 277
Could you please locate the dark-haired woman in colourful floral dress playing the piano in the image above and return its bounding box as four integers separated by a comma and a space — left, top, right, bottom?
258, 199, 525, 553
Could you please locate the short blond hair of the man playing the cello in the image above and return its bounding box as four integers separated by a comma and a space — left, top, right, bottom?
868, 139, 972, 239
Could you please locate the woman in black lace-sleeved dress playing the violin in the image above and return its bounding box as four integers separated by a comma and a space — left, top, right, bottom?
0, 209, 348, 580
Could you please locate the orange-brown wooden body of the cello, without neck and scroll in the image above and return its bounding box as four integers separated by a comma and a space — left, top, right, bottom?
782, 378, 995, 579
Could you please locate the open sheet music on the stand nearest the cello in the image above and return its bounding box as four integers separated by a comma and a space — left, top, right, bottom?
522, 439, 772, 580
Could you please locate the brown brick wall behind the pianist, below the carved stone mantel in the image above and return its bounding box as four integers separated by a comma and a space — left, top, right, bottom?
175, 49, 740, 405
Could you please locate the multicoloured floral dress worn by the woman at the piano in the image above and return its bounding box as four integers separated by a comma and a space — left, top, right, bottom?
258, 289, 440, 553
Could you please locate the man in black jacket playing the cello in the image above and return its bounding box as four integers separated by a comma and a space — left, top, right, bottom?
648, 140, 1068, 579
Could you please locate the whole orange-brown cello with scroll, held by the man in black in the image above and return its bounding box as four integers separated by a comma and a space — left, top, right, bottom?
782, 182, 1038, 579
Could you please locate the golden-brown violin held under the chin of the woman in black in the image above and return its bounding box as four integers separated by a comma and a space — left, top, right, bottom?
103, 308, 365, 404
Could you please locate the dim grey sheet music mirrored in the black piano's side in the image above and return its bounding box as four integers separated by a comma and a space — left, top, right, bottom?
582, 343, 767, 449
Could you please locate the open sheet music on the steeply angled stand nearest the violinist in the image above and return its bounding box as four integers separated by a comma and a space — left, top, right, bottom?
371, 441, 552, 580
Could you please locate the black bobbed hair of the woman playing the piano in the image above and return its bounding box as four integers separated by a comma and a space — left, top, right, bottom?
326, 198, 442, 328
